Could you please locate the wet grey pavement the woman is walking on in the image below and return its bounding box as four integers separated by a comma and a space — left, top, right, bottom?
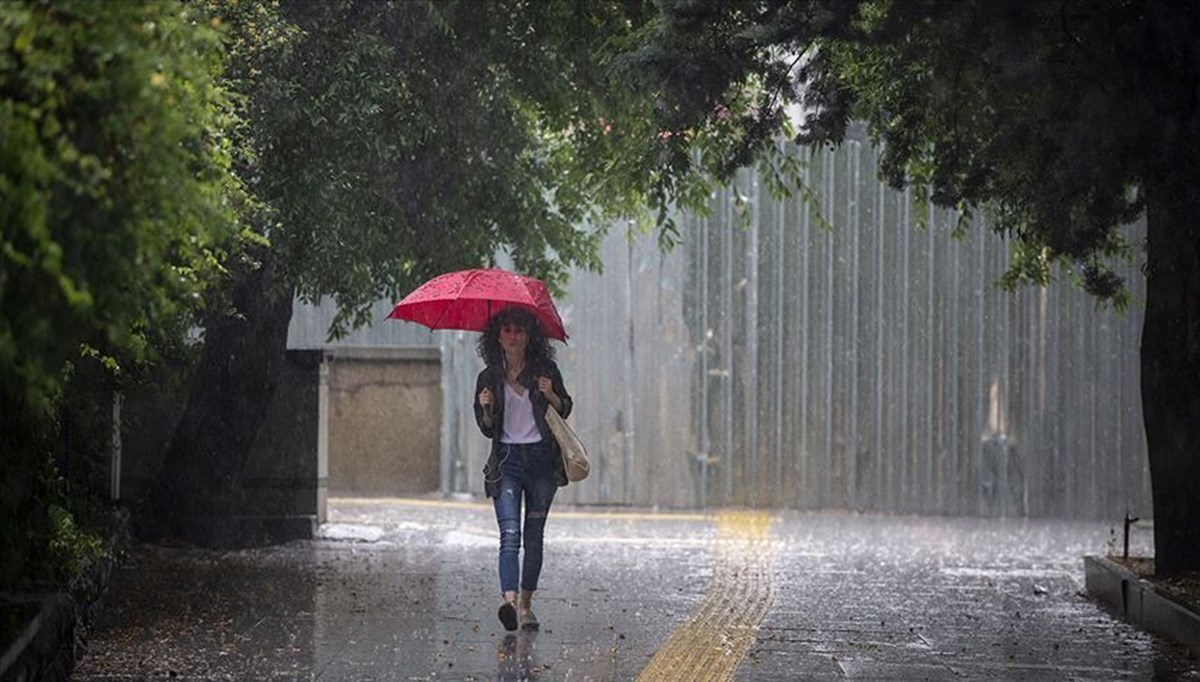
72, 499, 1200, 681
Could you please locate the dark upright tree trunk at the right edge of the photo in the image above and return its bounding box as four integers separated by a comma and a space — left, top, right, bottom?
1141, 170, 1200, 575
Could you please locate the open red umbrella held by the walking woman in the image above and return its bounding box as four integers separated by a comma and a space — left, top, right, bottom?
388, 268, 566, 343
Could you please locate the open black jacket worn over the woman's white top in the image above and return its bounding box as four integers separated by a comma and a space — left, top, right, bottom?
475, 361, 574, 497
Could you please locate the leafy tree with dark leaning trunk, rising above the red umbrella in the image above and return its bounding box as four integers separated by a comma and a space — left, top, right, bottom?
142, 0, 700, 539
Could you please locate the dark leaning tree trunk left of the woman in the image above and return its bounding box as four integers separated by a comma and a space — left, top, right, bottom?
138, 255, 293, 546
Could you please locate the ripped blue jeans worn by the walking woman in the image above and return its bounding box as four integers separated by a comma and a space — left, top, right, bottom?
492, 442, 558, 592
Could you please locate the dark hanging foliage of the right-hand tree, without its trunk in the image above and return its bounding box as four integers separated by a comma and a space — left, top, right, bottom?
631, 0, 1195, 306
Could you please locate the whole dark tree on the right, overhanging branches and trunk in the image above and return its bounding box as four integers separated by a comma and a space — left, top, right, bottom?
629, 0, 1200, 574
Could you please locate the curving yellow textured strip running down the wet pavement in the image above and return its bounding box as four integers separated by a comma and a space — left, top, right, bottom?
637, 512, 773, 682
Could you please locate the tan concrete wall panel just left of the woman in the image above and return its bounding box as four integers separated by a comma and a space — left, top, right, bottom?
325, 347, 442, 497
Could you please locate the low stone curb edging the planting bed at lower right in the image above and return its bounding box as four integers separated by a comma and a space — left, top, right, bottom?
1084, 556, 1200, 656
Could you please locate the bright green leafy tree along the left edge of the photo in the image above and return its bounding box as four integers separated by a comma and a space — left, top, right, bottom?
0, 0, 240, 580
